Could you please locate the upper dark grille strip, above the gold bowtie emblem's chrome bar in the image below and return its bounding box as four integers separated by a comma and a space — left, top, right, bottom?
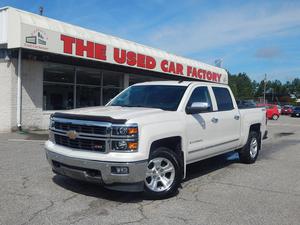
54, 121, 108, 135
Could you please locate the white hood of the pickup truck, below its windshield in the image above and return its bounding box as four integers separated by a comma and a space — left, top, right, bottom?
64, 106, 166, 120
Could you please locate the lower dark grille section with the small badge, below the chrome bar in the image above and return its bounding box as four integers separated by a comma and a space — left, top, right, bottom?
54, 134, 106, 152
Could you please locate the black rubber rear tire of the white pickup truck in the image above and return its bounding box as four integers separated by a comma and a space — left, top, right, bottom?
239, 131, 260, 164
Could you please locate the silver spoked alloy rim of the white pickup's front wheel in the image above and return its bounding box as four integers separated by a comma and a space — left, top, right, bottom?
145, 157, 175, 192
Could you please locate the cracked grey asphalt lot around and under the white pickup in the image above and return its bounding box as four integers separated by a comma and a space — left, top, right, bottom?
0, 116, 300, 225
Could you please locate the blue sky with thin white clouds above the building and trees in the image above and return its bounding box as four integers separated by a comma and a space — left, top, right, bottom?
0, 0, 300, 82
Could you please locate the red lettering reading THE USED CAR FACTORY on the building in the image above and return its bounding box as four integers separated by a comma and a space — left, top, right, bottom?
60, 35, 222, 82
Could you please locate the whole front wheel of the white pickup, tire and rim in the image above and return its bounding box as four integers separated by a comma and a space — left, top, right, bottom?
145, 147, 182, 199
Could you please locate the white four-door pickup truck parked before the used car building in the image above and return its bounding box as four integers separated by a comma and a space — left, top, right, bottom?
45, 81, 266, 198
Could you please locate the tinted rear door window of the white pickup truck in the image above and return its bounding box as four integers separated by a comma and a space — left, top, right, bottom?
213, 87, 233, 111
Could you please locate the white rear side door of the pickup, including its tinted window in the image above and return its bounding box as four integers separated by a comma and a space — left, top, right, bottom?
212, 87, 241, 152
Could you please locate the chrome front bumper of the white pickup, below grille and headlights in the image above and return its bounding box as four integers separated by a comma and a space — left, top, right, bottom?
46, 149, 147, 191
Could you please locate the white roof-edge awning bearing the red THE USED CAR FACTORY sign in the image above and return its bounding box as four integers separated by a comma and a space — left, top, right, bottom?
0, 7, 228, 84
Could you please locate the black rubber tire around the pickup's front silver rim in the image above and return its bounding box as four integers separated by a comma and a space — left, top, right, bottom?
144, 147, 183, 199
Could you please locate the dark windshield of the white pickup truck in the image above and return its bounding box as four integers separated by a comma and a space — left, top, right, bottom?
109, 85, 187, 111
